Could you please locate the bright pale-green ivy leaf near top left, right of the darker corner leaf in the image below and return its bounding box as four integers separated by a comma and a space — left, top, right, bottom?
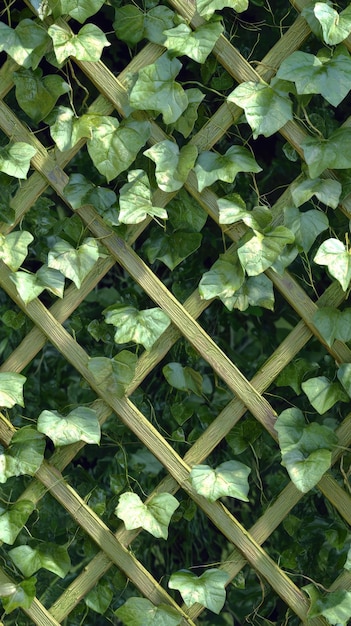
48, 24, 111, 64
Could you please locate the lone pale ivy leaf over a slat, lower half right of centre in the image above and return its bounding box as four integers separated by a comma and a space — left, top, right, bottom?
189, 461, 251, 502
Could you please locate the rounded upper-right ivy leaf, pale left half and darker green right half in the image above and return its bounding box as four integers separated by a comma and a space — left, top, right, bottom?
227, 80, 293, 139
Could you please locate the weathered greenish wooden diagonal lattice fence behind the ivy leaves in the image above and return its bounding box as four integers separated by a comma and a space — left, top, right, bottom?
0, 0, 351, 626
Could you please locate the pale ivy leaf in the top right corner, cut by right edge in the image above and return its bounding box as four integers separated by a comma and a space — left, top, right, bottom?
313, 2, 351, 46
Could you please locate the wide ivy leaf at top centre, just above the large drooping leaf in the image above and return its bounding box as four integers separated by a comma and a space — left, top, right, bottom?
163, 18, 223, 63
